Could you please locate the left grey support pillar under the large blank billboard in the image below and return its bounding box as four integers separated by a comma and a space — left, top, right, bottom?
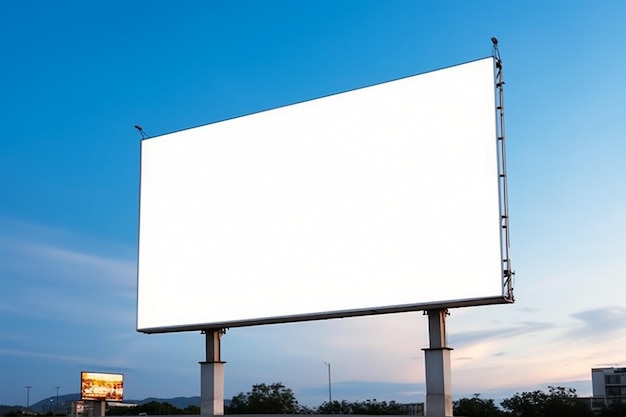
200, 329, 226, 416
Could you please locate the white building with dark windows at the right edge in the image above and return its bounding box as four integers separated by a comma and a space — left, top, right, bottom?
591, 368, 626, 410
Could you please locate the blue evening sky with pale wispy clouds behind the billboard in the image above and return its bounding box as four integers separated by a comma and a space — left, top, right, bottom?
0, 0, 626, 406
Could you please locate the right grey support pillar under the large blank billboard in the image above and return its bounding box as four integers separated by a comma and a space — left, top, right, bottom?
422, 309, 452, 417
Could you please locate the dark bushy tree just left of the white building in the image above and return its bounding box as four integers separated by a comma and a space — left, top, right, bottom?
501, 387, 593, 417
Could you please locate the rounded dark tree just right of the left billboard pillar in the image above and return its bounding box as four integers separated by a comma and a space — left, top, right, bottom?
225, 382, 300, 414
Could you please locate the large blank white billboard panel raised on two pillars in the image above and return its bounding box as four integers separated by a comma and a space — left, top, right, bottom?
137, 58, 506, 333
